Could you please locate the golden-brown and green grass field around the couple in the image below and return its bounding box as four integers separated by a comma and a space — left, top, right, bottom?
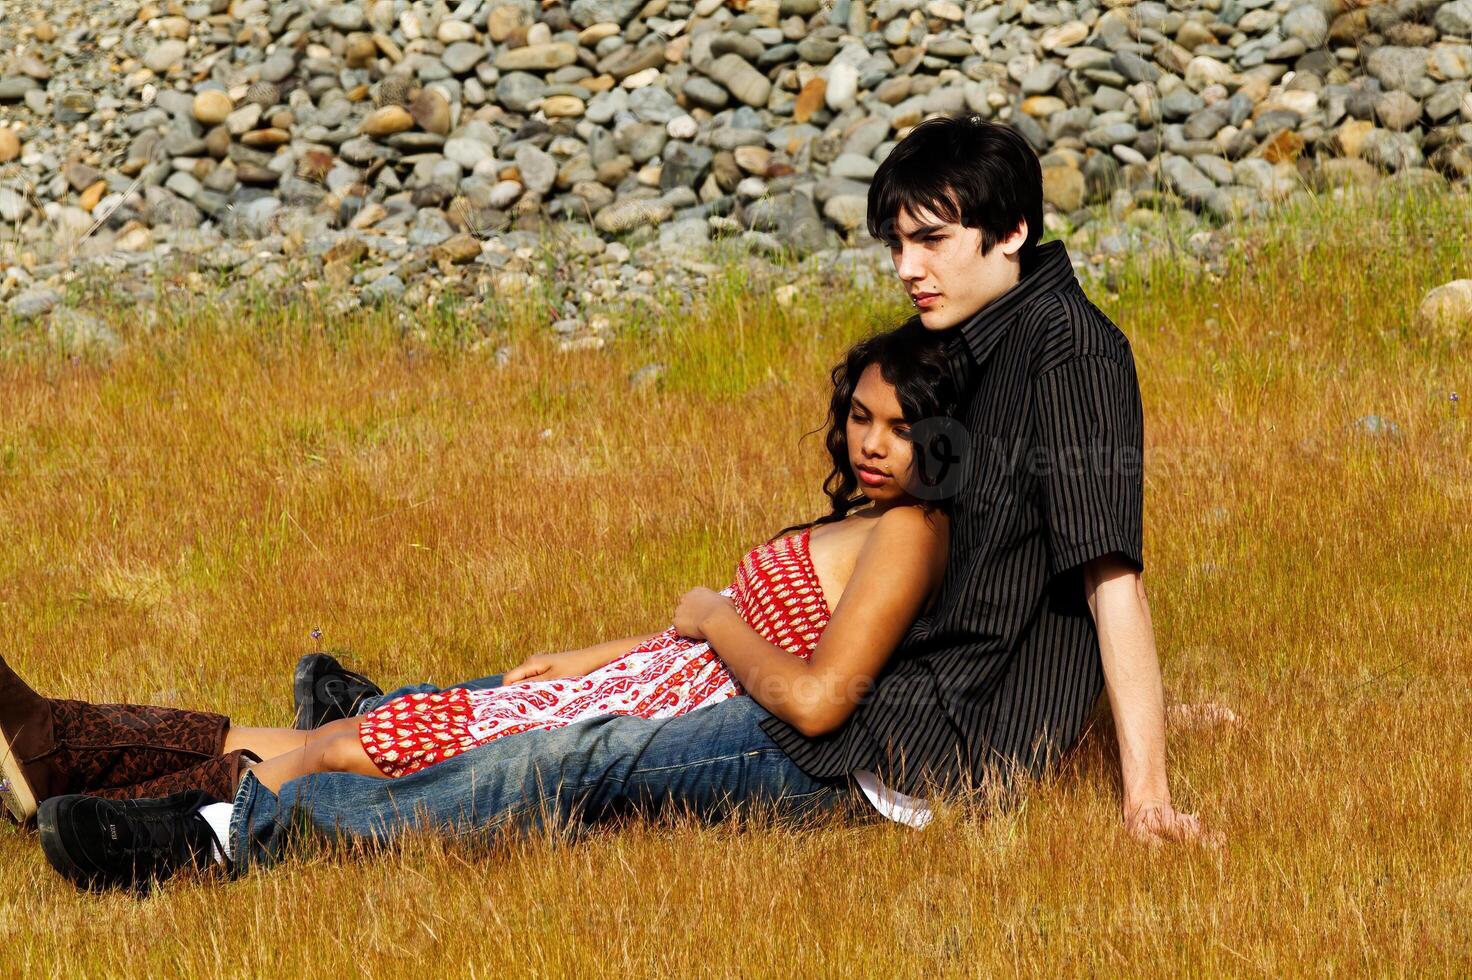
0, 186, 1472, 977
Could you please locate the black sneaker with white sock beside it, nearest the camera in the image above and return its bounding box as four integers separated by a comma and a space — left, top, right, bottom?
35, 790, 221, 892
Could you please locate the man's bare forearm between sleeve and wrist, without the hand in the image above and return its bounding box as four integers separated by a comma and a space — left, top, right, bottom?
1091, 574, 1170, 815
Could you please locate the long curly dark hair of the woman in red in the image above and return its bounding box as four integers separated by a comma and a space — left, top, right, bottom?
771, 316, 958, 540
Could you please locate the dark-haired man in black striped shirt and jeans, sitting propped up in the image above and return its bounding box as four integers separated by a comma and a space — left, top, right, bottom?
41, 116, 1201, 884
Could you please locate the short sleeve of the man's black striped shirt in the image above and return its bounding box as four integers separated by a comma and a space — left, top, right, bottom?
1033, 353, 1145, 575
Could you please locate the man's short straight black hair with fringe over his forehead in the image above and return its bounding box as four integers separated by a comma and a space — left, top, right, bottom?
868, 113, 1042, 271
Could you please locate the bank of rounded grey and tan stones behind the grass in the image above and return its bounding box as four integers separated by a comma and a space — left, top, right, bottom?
0, 0, 1472, 320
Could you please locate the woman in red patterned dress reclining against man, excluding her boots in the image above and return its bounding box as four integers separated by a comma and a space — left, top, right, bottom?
2, 321, 955, 799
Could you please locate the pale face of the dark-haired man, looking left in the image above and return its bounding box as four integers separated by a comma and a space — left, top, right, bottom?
889, 204, 1027, 330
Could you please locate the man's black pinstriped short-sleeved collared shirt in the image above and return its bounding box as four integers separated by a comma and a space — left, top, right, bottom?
762, 241, 1144, 795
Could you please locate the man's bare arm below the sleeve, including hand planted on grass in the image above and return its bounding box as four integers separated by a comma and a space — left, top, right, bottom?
1083, 555, 1219, 843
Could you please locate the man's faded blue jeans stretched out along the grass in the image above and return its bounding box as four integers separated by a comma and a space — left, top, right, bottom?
230, 678, 877, 873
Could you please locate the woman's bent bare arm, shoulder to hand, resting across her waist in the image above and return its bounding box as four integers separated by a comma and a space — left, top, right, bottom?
674, 506, 948, 737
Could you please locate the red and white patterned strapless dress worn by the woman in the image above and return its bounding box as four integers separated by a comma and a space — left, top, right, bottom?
359, 528, 829, 777
